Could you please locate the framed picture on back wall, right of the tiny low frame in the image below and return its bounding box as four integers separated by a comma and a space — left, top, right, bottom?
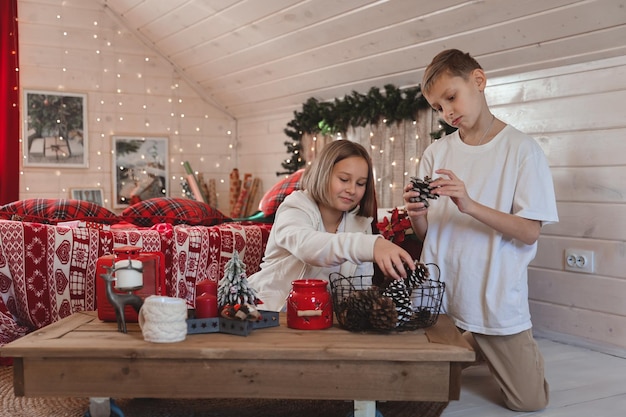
112, 135, 169, 208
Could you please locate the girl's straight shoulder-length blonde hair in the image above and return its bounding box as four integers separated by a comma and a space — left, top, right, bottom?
302, 139, 377, 217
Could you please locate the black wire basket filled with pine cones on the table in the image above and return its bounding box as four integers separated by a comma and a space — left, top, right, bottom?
329, 263, 445, 332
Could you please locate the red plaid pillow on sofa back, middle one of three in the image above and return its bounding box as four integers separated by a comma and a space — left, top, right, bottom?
120, 197, 231, 227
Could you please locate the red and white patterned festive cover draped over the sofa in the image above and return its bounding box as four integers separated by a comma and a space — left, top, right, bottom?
0, 220, 271, 346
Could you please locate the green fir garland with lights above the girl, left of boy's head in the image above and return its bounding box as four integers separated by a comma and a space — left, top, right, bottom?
276, 84, 429, 175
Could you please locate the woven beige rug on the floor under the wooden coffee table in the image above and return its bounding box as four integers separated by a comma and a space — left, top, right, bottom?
0, 366, 448, 417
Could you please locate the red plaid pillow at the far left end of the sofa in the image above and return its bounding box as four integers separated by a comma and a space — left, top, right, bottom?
0, 198, 120, 224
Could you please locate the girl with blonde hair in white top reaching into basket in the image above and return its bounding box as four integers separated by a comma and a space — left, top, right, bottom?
248, 140, 415, 311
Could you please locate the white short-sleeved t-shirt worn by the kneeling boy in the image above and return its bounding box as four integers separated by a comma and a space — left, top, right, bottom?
418, 125, 558, 335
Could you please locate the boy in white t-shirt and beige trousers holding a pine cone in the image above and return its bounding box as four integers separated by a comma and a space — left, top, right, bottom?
404, 50, 558, 411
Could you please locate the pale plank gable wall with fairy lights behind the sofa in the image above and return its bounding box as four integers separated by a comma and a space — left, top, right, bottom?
18, 0, 237, 211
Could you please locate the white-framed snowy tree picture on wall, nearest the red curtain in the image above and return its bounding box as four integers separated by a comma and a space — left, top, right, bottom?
22, 90, 89, 168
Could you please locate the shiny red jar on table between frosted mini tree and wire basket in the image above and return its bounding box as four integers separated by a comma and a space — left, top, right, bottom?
287, 279, 333, 330
